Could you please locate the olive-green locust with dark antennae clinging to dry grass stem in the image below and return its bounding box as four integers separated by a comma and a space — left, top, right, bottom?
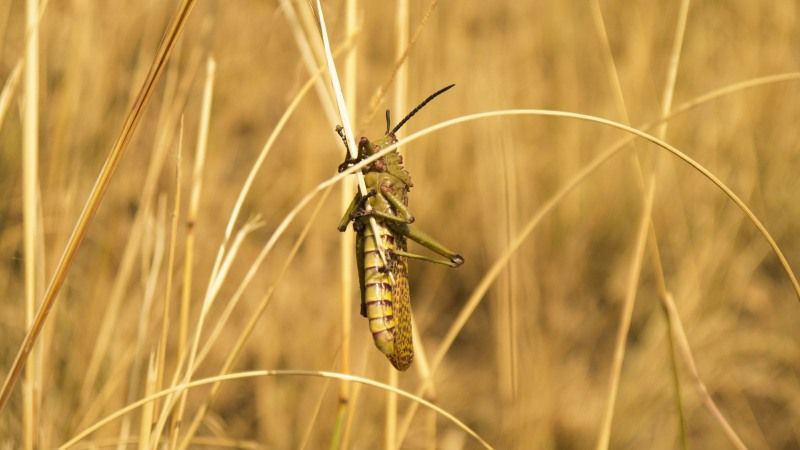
336, 84, 464, 371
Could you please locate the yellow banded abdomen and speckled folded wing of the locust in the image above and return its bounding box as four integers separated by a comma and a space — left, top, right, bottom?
361, 223, 414, 370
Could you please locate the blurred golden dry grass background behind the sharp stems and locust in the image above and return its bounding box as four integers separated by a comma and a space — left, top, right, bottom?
0, 0, 800, 449
